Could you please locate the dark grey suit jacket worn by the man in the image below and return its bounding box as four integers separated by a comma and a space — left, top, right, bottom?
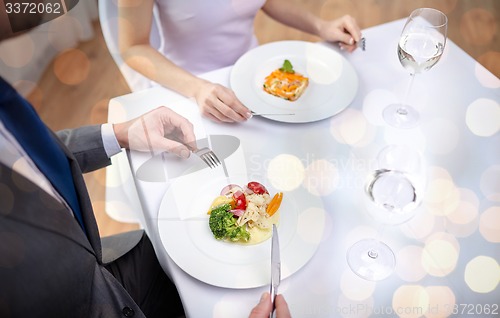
0, 126, 144, 318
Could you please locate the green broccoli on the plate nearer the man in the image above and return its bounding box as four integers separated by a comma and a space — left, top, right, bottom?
208, 204, 250, 241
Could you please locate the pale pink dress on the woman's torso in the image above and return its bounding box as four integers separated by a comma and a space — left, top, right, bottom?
155, 0, 265, 74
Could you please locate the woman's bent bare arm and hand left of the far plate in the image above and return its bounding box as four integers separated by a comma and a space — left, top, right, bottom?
118, 0, 250, 122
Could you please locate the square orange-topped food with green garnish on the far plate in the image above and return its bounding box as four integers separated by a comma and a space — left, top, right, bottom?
263, 60, 309, 101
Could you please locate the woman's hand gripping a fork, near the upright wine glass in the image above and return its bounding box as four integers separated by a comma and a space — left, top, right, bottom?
318, 15, 361, 52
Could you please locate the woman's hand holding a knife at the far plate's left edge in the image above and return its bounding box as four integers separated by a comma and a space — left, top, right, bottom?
194, 81, 252, 122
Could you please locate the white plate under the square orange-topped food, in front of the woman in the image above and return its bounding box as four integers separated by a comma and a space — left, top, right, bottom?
230, 41, 358, 123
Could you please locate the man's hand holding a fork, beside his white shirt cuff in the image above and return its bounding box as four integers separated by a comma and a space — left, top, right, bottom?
113, 106, 196, 158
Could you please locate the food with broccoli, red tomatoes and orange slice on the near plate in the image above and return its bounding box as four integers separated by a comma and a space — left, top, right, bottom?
208, 181, 283, 244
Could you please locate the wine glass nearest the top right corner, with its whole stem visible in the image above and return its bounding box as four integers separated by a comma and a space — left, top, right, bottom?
383, 8, 448, 128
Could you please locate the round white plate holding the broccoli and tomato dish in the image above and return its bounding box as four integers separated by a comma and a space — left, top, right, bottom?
158, 175, 325, 288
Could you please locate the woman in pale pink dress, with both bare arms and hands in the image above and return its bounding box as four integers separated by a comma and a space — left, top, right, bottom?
118, 0, 361, 122
